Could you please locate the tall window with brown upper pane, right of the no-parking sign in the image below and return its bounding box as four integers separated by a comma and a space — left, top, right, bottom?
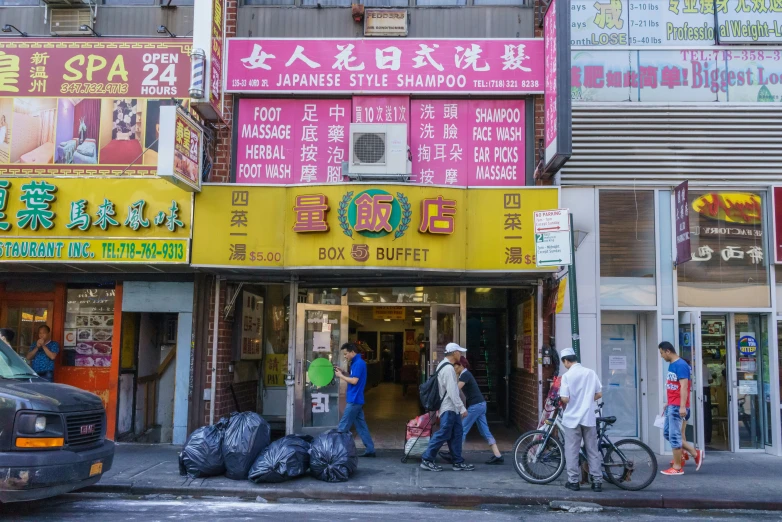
600, 190, 657, 306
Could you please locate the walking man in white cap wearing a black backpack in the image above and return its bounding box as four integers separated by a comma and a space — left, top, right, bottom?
421, 343, 475, 471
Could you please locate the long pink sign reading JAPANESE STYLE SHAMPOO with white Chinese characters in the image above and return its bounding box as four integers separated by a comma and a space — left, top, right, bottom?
225, 38, 544, 94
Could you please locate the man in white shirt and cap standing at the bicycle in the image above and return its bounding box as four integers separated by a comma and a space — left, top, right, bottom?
559, 348, 603, 492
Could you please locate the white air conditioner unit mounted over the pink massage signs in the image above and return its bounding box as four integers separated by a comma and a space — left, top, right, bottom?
348, 123, 412, 181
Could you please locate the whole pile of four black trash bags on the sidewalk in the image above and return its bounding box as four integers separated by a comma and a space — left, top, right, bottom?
179, 412, 358, 483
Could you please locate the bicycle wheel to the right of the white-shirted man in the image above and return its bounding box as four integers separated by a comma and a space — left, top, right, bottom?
603, 439, 657, 491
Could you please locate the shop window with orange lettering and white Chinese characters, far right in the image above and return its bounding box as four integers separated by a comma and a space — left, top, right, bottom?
677, 191, 770, 308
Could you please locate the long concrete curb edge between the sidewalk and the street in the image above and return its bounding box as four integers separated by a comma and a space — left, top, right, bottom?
83, 483, 782, 511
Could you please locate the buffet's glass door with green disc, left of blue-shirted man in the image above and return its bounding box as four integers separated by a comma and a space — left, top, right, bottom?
294, 303, 348, 433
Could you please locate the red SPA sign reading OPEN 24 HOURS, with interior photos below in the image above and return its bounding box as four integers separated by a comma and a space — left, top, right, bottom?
0, 38, 191, 176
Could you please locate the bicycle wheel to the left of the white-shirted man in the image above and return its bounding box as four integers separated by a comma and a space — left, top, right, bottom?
513, 430, 565, 484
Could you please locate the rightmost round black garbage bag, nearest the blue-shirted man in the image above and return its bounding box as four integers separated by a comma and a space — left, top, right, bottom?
310, 430, 358, 482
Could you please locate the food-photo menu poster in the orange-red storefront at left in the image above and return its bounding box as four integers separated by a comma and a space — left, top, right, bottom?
62, 288, 114, 368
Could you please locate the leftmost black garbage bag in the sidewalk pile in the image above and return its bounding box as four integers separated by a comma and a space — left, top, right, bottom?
179, 417, 233, 478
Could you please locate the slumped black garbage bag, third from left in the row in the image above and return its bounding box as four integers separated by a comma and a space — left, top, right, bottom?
249, 435, 312, 483
